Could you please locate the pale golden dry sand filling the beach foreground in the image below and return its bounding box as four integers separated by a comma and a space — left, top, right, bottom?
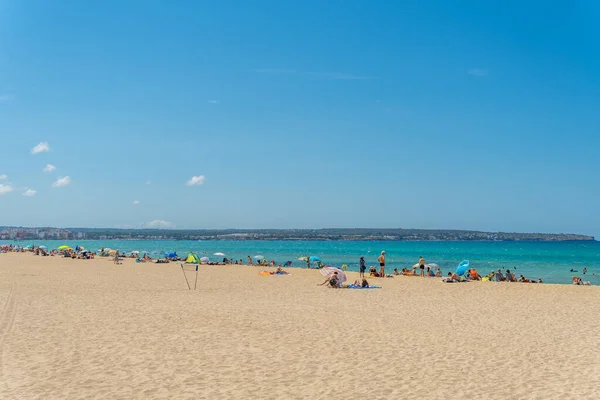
0, 254, 600, 399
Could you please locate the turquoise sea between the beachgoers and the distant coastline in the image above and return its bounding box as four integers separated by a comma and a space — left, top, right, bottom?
5, 240, 600, 285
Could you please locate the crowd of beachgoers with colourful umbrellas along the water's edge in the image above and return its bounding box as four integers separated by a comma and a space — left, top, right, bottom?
0, 244, 590, 288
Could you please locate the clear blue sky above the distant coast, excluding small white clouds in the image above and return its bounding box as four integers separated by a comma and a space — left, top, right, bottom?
0, 0, 600, 236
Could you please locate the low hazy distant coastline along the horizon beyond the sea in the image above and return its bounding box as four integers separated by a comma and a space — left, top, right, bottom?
0, 226, 595, 242
